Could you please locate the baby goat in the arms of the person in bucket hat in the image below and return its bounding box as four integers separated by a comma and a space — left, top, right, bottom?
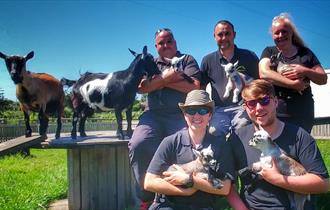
167, 145, 223, 189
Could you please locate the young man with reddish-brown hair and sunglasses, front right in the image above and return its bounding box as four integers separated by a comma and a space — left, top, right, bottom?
228, 79, 329, 210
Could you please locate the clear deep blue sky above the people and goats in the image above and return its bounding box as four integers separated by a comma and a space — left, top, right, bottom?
0, 0, 330, 100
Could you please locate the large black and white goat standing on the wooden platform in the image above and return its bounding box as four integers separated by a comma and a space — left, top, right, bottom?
61, 46, 161, 139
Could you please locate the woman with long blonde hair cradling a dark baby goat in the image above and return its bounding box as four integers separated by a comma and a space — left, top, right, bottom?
259, 13, 327, 133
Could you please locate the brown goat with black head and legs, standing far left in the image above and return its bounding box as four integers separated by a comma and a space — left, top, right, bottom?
0, 51, 64, 138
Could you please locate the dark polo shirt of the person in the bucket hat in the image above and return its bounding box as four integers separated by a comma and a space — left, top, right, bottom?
147, 128, 234, 206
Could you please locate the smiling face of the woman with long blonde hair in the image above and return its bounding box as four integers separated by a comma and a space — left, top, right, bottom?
272, 19, 293, 50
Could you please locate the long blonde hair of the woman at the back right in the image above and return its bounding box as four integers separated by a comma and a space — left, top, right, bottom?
270, 12, 306, 47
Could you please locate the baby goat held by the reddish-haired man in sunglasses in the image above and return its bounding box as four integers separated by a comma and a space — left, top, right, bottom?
249, 130, 309, 210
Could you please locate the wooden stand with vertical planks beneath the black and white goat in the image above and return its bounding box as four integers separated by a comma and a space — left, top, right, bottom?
43, 131, 134, 210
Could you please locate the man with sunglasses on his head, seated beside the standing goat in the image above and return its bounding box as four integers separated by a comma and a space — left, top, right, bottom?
128, 28, 201, 209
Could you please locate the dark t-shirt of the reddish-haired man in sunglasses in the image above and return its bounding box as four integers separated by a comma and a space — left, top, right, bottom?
228, 123, 329, 210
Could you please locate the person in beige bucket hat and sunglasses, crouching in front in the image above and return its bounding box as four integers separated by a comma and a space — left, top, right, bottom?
144, 90, 245, 210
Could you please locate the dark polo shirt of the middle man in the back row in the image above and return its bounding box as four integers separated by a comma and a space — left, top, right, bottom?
201, 46, 259, 107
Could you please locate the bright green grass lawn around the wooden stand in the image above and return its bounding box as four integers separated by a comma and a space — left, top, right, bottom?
0, 140, 330, 210
